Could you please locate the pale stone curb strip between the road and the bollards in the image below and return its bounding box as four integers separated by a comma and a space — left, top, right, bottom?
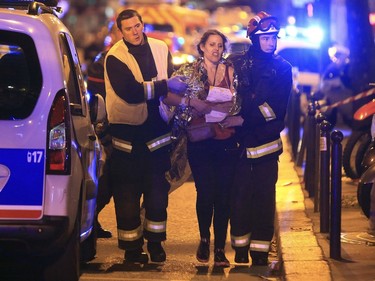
275, 136, 332, 281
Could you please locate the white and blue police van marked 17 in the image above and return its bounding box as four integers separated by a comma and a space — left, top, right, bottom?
0, 0, 105, 281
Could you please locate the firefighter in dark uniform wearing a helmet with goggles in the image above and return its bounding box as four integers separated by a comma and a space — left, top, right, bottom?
221, 12, 292, 265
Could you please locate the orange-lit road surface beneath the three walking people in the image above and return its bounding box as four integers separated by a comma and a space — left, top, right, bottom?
80, 182, 280, 281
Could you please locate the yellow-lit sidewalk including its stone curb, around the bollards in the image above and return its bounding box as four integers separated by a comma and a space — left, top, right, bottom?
276, 133, 375, 281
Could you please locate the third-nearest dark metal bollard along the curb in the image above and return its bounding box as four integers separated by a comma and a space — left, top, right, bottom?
304, 101, 317, 197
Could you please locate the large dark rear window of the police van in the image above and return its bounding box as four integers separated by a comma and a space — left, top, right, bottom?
0, 31, 42, 120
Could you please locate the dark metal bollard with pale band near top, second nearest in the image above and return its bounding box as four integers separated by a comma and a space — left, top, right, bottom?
319, 120, 331, 233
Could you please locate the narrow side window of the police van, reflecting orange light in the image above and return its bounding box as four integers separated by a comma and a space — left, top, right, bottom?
59, 33, 85, 115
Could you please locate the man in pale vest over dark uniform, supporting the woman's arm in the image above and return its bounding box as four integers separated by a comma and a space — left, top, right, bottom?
104, 9, 187, 263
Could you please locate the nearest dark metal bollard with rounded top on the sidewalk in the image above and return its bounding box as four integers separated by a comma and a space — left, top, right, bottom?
329, 130, 344, 259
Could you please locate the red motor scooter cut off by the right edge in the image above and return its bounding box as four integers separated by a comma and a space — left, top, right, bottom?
354, 99, 375, 220
